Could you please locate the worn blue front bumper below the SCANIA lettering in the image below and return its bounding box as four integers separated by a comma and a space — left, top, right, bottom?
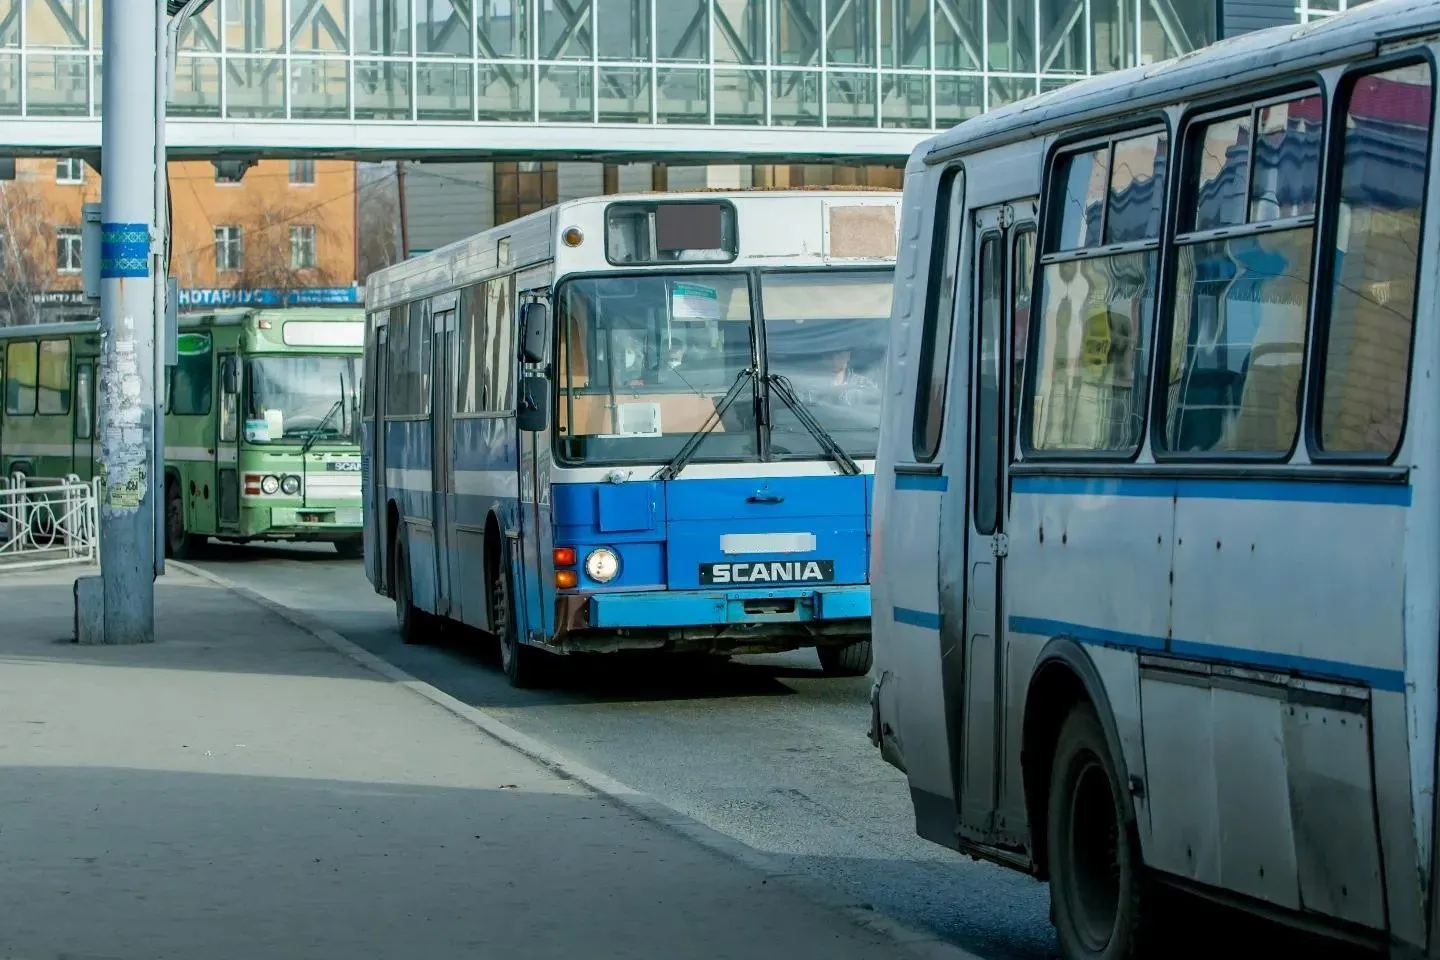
556, 584, 870, 653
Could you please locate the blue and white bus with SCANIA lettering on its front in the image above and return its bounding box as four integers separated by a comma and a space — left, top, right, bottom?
363, 191, 899, 685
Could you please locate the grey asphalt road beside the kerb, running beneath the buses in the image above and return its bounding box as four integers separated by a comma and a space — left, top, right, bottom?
199, 544, 1056, 960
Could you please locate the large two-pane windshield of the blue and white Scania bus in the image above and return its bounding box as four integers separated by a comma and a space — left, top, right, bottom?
556, 269, 893, 463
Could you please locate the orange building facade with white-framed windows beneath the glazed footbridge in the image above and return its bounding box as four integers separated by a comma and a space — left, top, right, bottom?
0, 158, 359, 322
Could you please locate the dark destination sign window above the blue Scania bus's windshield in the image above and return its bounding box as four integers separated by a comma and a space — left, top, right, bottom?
605, 201, 739, 265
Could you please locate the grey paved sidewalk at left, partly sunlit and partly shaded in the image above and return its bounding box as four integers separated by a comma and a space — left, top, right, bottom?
0, 569, 944, 960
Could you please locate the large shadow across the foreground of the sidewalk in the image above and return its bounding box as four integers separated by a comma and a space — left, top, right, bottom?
0, 765, 921, 960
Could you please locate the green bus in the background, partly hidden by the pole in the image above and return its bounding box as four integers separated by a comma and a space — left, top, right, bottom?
0, 307, 364, 558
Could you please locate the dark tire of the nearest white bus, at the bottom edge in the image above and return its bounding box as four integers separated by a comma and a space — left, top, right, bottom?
1045, 701, 1153, 960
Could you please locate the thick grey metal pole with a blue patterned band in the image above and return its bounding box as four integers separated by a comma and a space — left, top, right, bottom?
99, 0, 163, 643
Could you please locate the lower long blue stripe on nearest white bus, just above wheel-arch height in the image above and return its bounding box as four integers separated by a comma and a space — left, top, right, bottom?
1009, 616, 1405, 694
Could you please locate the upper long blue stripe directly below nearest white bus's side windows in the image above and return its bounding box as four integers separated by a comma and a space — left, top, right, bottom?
1008, 476, 1413, 507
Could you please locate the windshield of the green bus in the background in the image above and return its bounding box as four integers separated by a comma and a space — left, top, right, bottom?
246, 354, 360, 443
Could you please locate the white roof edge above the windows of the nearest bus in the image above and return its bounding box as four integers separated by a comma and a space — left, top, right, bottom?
914, 0, 1440, 164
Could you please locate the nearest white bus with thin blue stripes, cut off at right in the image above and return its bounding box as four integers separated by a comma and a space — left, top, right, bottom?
871, 0, 1440, 960
